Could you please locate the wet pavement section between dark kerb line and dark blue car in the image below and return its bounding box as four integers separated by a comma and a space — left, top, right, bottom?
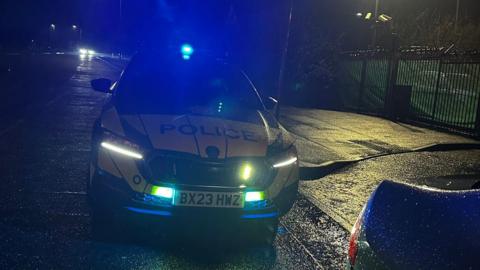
300, 150, 480, 230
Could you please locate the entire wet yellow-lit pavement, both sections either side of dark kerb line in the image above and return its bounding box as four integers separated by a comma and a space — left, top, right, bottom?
280, 107, 480, 230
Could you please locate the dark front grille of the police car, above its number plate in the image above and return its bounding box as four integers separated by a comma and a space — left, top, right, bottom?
148, 156, 272, 187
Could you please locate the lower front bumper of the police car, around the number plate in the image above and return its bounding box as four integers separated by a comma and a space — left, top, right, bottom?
89, 170, 278, 223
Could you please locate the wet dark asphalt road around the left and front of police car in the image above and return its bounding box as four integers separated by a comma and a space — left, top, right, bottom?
0, 55, 348, 269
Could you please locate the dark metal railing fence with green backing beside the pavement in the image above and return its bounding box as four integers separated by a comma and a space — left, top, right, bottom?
337, 50, 480, 136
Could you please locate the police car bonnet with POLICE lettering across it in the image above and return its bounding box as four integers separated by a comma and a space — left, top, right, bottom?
103, 108, 291, 159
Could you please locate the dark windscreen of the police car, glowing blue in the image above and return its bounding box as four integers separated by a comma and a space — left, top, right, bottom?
115, 55, 263, 114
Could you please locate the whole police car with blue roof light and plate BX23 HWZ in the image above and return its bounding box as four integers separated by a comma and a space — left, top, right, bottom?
87, 46, 299, 242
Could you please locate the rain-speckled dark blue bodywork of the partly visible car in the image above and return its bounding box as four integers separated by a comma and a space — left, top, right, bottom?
363, 181, 480, 269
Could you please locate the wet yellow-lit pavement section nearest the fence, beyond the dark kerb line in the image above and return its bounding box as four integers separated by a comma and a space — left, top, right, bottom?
280, 107, 480, 167
